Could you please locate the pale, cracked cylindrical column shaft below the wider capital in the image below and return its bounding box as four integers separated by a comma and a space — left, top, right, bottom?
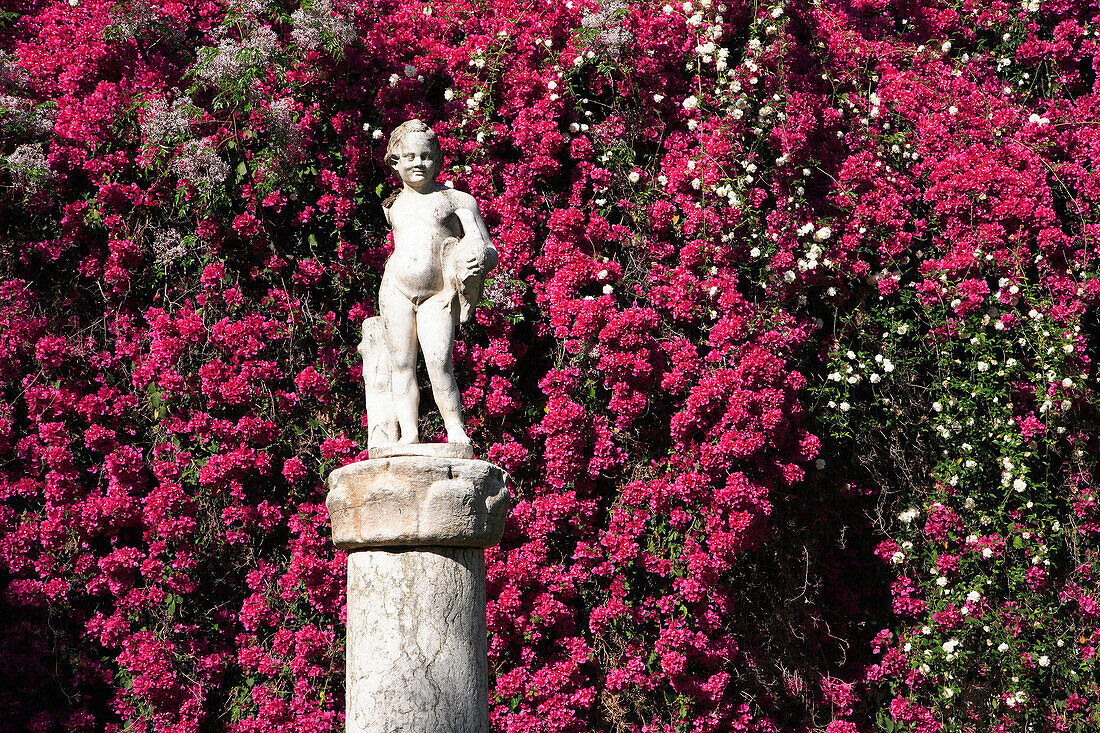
347, 547, 488, 733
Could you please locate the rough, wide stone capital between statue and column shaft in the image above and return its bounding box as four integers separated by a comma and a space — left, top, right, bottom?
325, 456, 509, 550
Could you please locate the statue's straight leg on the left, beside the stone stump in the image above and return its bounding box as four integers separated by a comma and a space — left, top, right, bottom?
378, 278, 420, 444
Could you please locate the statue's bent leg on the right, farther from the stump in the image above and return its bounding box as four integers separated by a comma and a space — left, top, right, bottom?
416, 292, 470, 442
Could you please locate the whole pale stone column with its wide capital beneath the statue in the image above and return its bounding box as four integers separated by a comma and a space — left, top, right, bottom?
326, 444, 508, 733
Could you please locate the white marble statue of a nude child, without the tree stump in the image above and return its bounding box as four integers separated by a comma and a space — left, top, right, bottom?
376, 120, 497, 445
